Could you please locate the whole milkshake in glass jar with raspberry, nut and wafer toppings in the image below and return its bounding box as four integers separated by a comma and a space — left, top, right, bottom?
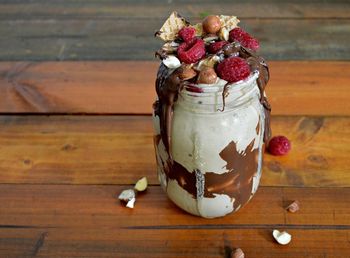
153, 12, 271, 218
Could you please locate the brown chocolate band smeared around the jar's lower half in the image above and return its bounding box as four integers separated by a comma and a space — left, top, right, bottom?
164, 140, 259, 209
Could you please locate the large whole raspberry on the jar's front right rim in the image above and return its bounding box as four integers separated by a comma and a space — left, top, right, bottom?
216, 57, 250, 82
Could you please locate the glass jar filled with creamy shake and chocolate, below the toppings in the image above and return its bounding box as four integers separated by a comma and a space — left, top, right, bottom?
153, 72, 265, 218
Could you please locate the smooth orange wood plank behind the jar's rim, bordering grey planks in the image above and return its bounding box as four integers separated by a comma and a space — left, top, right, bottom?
0, 61, 350, 115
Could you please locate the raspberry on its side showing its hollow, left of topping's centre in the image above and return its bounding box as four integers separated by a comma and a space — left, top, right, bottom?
177, 38, 205, 64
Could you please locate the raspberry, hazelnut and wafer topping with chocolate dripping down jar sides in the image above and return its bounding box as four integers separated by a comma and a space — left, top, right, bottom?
154, 12, 271, 157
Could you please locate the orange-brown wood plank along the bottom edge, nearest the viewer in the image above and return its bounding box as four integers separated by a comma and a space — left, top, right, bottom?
0, 228, 350, 258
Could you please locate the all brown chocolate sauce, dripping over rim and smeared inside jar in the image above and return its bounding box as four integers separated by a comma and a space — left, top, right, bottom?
153, 39, 271, 209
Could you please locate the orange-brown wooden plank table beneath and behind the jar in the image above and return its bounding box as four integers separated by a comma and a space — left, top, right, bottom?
0, 0, 350, 258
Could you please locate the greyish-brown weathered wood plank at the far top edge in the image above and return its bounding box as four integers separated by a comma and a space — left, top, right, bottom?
0, 0, 350, 19
